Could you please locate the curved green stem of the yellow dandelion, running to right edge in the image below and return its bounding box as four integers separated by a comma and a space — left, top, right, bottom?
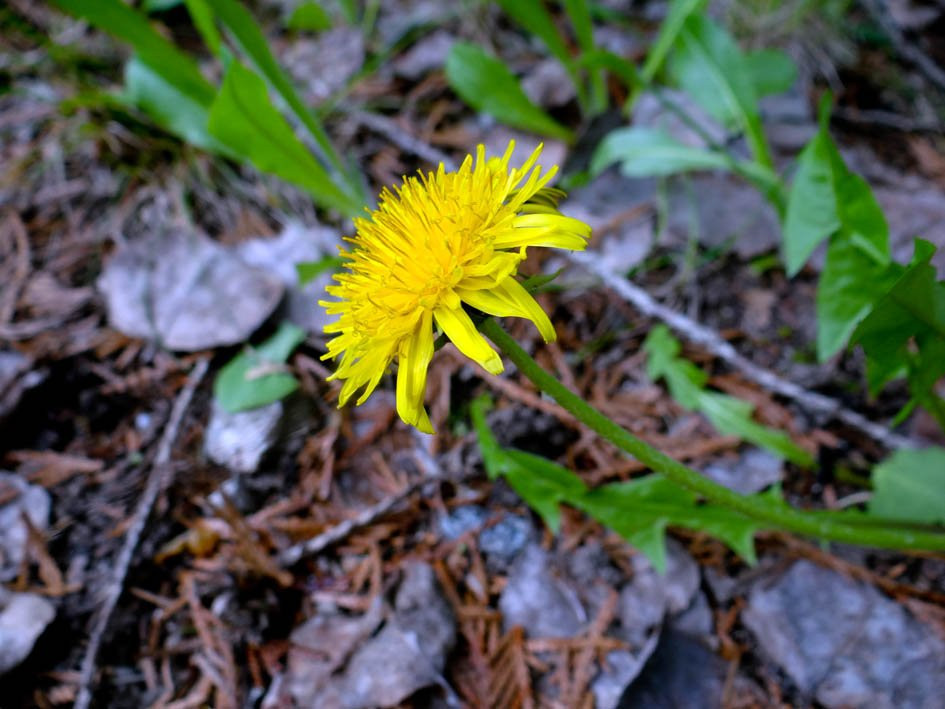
479, 318, 945, 551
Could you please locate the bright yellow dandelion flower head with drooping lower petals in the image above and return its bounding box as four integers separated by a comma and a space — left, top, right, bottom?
320, 143, 590, 433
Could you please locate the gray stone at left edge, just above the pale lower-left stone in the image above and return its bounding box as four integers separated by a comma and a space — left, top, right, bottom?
0, 472, 50, 582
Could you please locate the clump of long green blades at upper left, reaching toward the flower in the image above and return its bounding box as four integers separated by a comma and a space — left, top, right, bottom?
53, 0, 366, 216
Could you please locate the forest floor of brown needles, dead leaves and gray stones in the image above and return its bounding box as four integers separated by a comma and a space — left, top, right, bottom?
0, 0, 945, 709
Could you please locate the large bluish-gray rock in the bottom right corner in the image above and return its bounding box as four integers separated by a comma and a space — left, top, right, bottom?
742, 561, 945, 709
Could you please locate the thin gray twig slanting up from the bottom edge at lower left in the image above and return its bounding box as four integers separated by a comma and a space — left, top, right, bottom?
72, 357, 210, 709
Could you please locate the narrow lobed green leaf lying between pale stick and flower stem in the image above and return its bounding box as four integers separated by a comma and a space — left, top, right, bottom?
643, 325, 814, 467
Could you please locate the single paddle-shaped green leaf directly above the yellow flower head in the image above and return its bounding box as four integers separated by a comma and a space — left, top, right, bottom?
446, 42, 574, 142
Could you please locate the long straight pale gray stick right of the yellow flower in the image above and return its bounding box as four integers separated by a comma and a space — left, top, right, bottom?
568, 252, 916, 450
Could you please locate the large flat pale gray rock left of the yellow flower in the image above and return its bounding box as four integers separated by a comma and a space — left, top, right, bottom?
98, 229, 282, 352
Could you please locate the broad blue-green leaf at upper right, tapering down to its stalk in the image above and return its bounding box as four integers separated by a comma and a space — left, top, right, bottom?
669, 15, 771, 166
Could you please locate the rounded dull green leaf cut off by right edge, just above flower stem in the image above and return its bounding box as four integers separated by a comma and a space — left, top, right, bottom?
868, 448, 945, 524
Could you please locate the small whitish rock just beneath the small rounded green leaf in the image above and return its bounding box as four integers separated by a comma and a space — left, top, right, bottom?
203, 400, 284, 473
